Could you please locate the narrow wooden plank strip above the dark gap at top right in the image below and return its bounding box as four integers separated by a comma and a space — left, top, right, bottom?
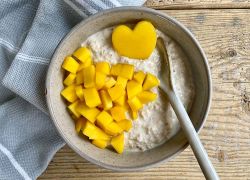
145, 0, 250, 9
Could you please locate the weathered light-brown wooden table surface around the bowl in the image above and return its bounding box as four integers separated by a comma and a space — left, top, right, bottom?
39, 0, 250, 180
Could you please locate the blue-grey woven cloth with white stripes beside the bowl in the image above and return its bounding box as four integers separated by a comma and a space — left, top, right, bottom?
0, 0, 144, 180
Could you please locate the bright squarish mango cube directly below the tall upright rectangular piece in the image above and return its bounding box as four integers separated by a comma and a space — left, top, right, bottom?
83, 88, 102, 108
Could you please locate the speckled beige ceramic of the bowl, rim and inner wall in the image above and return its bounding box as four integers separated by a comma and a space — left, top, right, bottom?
46, 7, 211, 171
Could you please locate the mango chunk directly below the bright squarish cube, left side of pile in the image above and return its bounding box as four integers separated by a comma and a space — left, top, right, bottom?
76, 102, 100, 123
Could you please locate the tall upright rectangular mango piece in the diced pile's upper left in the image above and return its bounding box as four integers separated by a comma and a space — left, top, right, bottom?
83, 65, 95, 88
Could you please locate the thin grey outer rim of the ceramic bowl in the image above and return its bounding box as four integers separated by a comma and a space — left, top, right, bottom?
45, 6, 212, 172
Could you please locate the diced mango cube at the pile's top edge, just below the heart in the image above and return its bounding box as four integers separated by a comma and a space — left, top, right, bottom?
110, 63, 134, 80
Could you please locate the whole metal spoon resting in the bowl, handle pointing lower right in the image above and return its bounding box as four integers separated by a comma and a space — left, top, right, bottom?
157, 37, 219, 180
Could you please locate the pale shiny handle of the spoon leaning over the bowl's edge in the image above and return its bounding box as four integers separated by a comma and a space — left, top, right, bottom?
165, 90, 219, 180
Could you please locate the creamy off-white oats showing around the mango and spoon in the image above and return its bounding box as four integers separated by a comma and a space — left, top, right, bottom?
82, 28, 194, 151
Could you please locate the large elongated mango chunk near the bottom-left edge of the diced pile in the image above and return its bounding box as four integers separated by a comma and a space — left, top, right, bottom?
82, 121, 110, 141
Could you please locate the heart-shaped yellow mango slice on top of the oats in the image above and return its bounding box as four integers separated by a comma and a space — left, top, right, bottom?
112, 21, 157, 59
